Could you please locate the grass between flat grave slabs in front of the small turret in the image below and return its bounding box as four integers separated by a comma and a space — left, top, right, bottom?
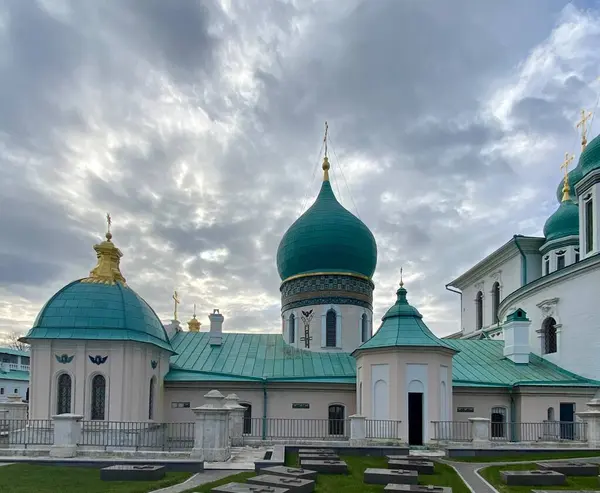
285, 454, 470, 493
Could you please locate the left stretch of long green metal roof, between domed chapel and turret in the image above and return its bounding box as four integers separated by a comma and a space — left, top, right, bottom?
167, 332, 356, 383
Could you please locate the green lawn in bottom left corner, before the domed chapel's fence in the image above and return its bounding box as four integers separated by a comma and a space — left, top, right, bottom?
0, 464, 191, 493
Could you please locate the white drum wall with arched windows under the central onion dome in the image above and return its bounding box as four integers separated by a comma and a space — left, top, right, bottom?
283, 304, 373, 352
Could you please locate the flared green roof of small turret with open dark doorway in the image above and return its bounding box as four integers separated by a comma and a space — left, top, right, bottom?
357, 286, 453, 351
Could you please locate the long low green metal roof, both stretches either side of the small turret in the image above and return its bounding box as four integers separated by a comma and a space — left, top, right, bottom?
165, 332, 600, 388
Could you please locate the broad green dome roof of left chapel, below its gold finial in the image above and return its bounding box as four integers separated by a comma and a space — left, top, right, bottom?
23, 280, 173, 352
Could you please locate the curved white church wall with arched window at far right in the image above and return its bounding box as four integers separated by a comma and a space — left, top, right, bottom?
500, 257, 600, 379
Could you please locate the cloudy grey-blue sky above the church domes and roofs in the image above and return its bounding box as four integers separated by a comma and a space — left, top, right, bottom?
0, 0, 600, 338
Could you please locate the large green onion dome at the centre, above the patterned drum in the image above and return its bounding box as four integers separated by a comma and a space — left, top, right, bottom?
277, 160, 377, 281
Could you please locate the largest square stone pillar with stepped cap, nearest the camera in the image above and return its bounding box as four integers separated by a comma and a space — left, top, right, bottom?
190, 390, 231, 462
